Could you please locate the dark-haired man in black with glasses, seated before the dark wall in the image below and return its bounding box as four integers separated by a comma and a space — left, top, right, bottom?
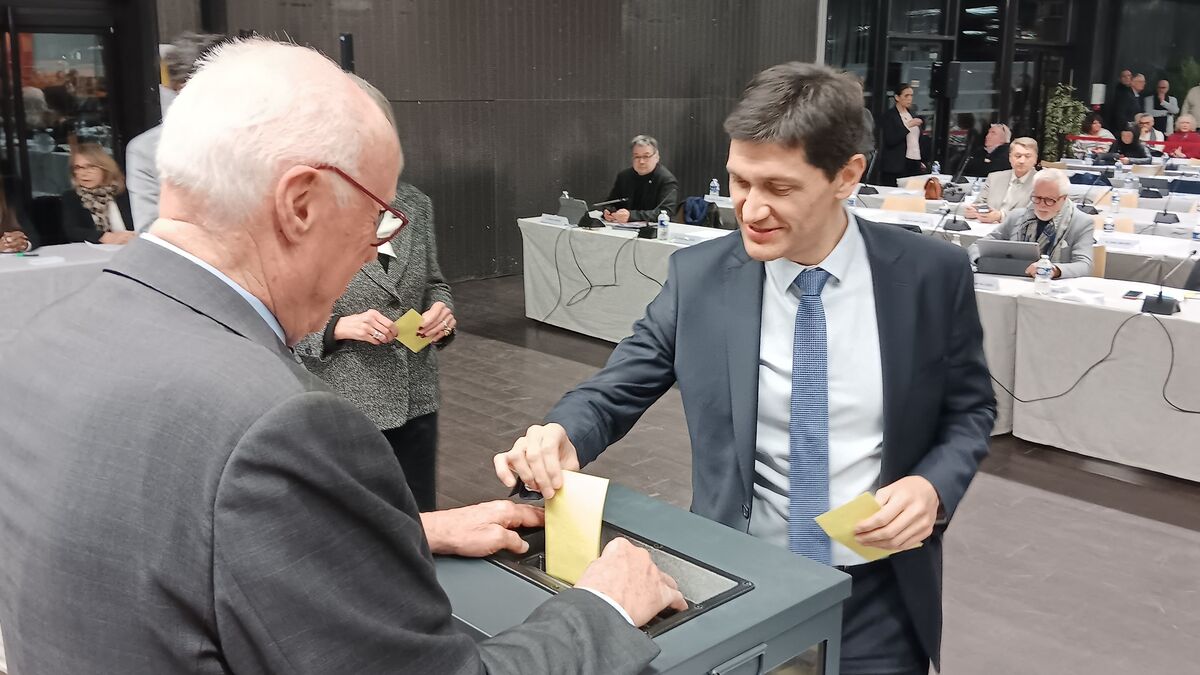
604, 136, 679, 222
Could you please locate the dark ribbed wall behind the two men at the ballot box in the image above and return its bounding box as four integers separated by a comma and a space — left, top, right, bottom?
220, 0, 818, 279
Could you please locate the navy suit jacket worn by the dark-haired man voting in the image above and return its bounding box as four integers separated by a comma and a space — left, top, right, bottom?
546, 219, 996, 665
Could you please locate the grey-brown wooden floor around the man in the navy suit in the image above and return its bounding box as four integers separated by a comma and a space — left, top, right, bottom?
438, 276, 1200, 675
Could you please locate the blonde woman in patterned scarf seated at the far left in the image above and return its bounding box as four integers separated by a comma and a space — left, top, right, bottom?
62, 143, 137, 244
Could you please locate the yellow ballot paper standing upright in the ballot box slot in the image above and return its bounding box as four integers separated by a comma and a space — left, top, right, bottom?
546, 471, 608, 584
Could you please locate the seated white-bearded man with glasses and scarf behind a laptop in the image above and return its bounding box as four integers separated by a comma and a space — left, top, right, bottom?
968, 169, 1096, 279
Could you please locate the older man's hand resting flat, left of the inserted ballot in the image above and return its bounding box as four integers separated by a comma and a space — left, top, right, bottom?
421, 501, 546, 557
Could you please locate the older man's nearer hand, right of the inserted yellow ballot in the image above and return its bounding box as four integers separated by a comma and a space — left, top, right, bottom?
575, 537, 688, 626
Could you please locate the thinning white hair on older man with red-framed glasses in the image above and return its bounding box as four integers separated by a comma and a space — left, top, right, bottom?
157, 37, 386, 222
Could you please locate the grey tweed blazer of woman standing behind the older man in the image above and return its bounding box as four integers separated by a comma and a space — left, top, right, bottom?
296, 183, 454, 429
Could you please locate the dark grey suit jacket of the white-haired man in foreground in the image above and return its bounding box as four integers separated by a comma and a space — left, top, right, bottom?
0, 240, 658, 675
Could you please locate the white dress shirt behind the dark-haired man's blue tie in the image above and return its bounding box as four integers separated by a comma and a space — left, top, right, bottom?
750, 211, 883, 566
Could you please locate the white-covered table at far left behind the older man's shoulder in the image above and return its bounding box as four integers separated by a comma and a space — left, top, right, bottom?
0, 244, 120, 345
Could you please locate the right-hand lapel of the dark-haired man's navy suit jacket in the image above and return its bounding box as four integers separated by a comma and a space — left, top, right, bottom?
858, 219, 917, 484
